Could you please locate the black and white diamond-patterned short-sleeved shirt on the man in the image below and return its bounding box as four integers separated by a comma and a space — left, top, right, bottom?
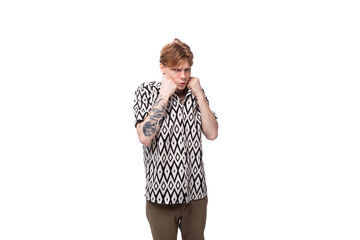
134, 82, 216, 204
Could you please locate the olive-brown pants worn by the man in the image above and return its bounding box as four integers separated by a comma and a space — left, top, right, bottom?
146, 197, 208, 240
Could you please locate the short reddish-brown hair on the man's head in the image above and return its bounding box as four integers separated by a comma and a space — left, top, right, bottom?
160, 38, 194, 67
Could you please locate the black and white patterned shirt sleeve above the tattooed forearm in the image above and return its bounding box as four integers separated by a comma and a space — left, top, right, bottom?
133, 83, 151, 127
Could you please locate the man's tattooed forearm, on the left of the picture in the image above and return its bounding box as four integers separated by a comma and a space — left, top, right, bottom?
136, 95, 168, 146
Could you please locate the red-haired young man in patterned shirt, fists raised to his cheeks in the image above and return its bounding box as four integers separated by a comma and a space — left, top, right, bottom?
134, 39, 218, 240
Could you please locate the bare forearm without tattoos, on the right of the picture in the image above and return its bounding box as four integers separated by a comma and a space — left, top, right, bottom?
197, 94, 218, 140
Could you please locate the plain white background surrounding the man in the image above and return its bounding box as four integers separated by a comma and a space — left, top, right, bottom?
0, 0, 360, 240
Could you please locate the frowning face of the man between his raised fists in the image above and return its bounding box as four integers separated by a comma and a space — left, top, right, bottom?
160, 59, 191, 91
